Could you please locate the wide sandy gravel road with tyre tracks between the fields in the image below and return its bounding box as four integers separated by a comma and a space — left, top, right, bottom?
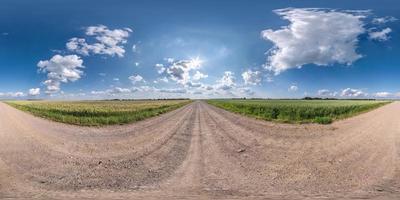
0, 101, 400, 199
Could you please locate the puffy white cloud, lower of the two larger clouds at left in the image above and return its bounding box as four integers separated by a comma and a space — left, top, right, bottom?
37, 55, 84, 93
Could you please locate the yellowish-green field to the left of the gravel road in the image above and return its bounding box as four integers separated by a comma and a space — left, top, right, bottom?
6, 100, 191, 126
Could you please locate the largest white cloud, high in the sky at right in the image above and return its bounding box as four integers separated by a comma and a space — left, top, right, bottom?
262, 8, 366, 74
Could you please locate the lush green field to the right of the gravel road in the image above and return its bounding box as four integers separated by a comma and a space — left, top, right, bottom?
207, 100, 390, 124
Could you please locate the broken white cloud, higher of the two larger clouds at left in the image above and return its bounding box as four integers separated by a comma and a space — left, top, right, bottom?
66, 25, 132, 57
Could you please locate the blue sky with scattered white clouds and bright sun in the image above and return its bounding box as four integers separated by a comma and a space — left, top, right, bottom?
0, 0, 400, 99
